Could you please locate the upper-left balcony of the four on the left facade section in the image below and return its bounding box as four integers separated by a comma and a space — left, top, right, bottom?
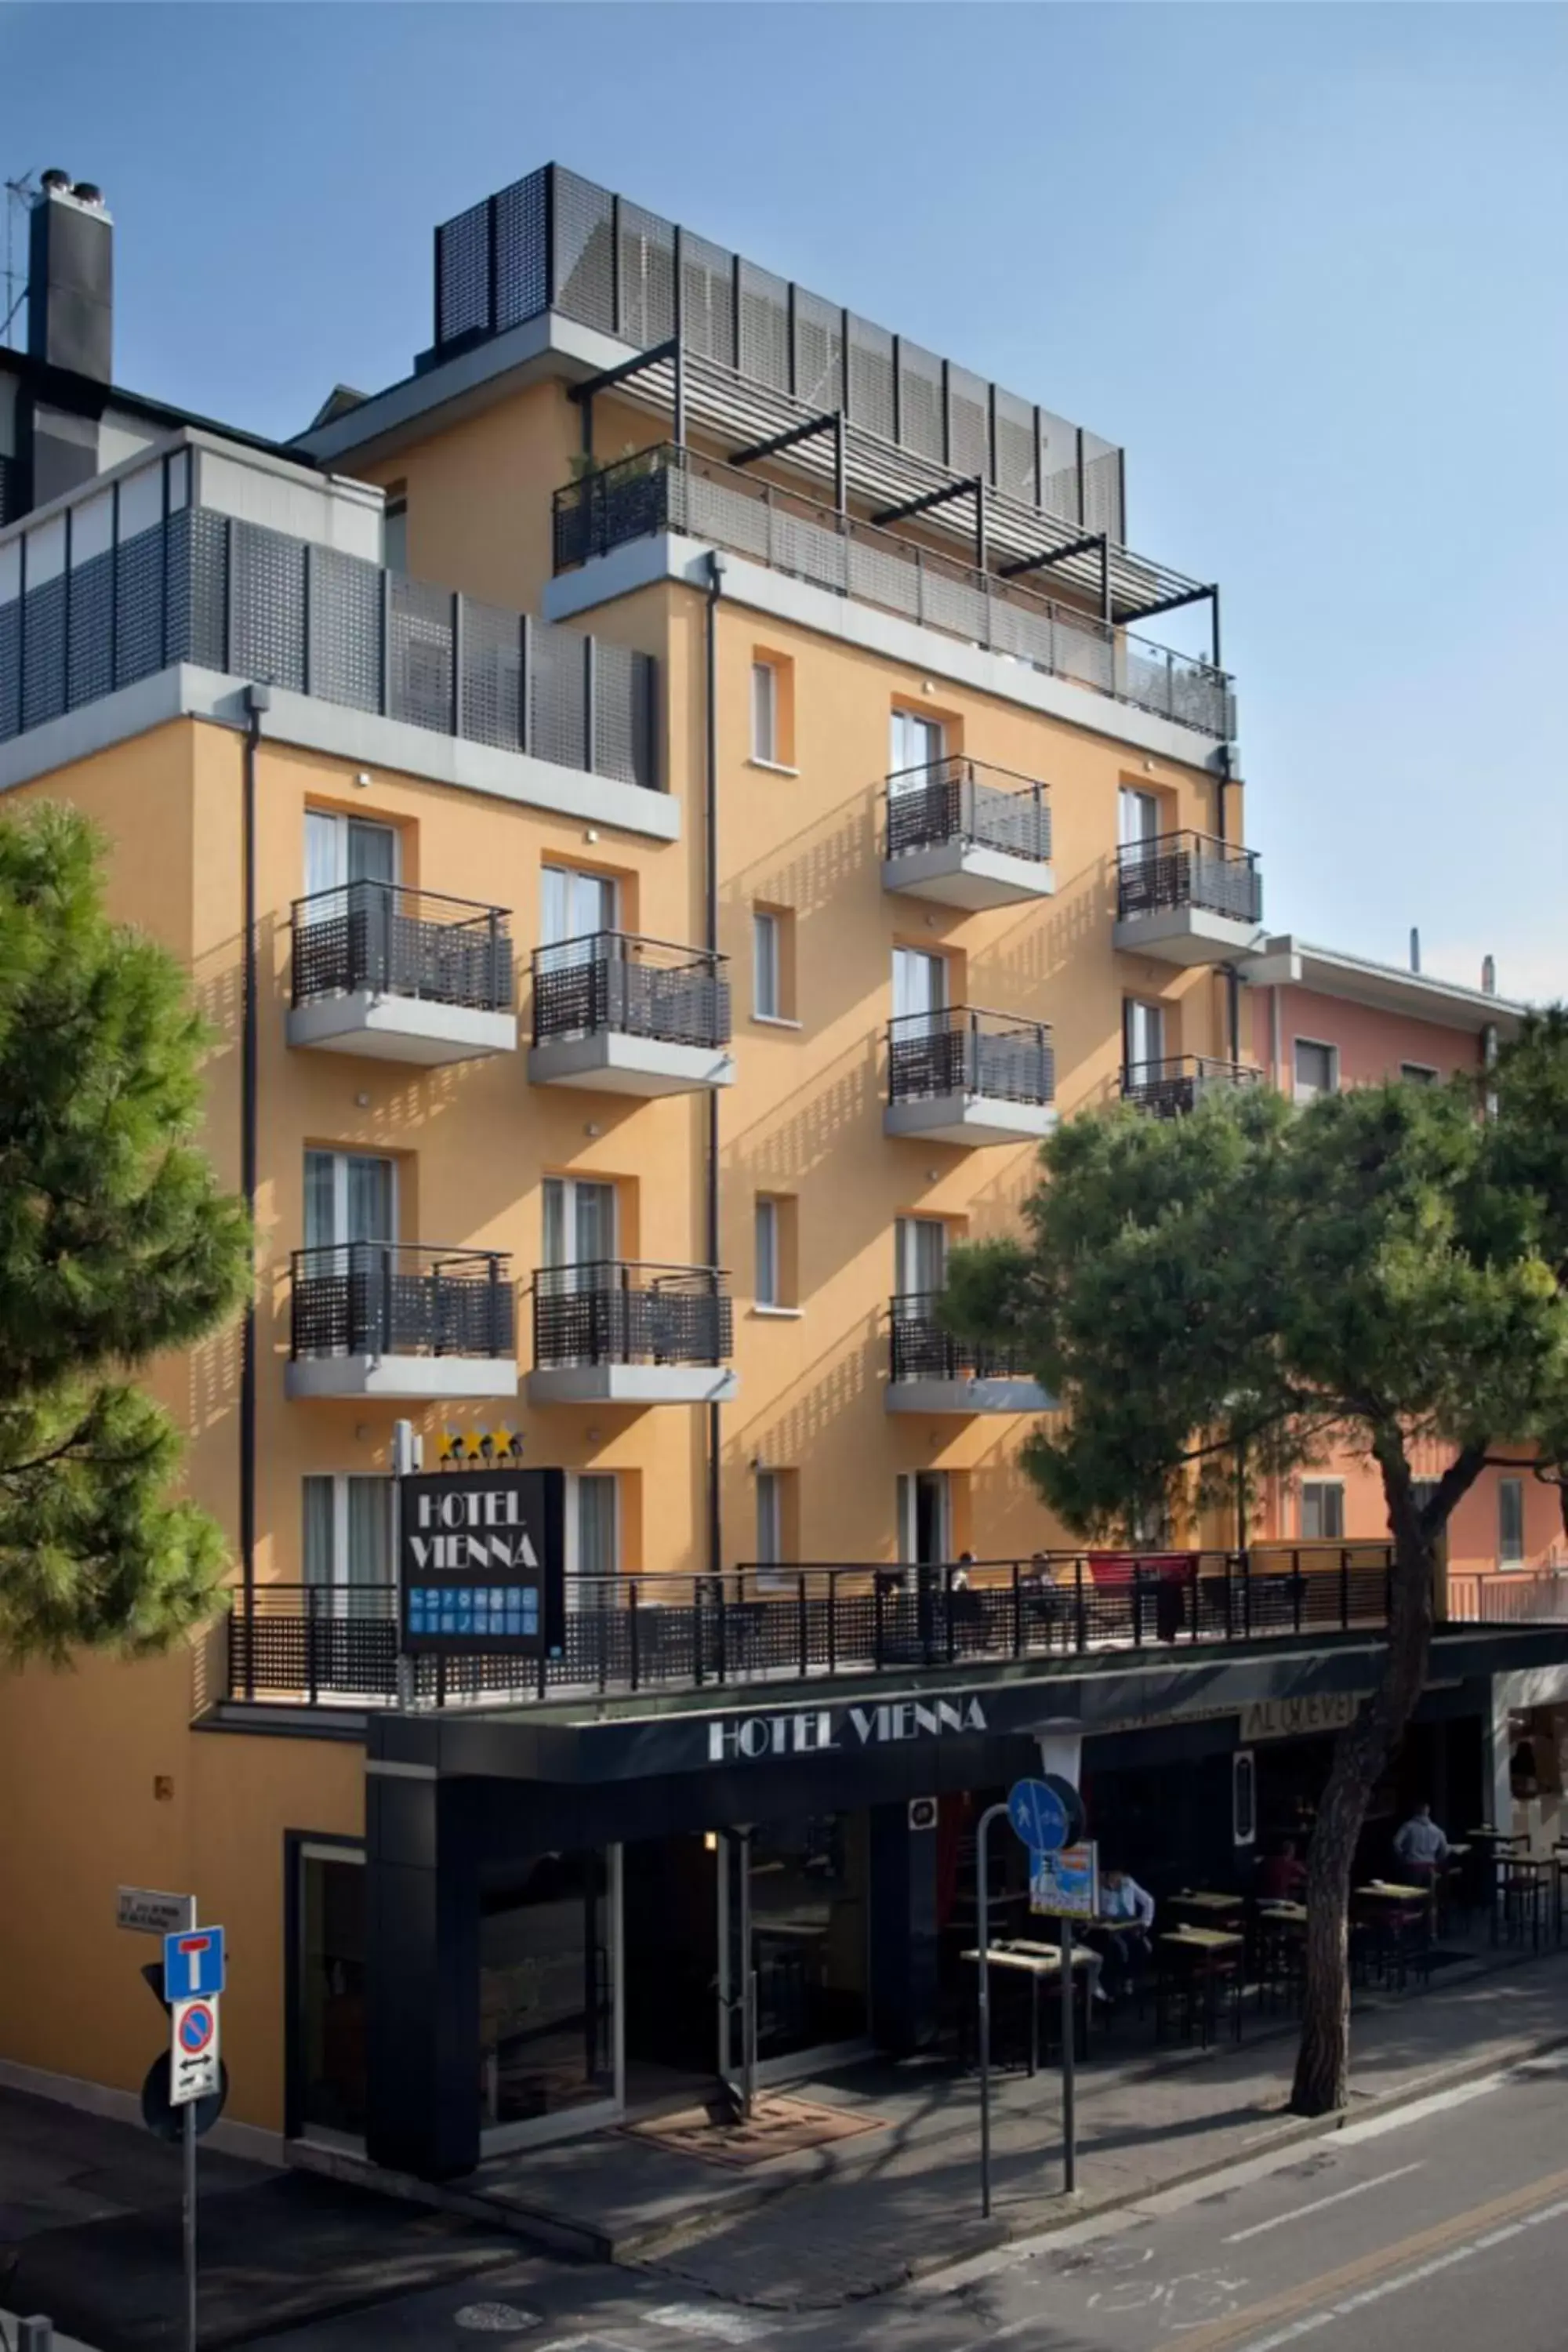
289, 882, 517, 1068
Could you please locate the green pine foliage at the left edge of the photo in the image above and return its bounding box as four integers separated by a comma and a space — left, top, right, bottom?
0, 804, 252, 1661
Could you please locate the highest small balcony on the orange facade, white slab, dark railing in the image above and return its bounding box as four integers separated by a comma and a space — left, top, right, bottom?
881, 757, 1055, 913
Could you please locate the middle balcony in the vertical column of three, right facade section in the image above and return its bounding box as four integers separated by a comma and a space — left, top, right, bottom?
881, 1004, 1055, 1143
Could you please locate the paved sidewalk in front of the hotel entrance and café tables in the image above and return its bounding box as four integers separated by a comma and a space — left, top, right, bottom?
409, 1955, 1568, 2310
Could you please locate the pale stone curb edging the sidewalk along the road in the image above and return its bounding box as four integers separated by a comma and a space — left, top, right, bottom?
639, 2032, 1568, 2312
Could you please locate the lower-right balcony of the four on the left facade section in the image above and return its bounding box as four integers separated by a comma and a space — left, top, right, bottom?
529, 1258, 736, 1404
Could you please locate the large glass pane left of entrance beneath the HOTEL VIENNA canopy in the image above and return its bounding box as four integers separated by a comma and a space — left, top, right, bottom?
480, 1851, 616, 2131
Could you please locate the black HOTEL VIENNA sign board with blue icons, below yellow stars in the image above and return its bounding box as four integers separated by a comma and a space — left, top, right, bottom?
397, 1468, 567, 1658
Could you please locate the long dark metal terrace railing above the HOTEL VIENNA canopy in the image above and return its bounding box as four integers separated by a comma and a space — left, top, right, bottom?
228, 1543, 1448, 1708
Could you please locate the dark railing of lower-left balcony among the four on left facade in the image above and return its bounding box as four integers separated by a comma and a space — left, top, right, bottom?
289, 1242, 517, 1357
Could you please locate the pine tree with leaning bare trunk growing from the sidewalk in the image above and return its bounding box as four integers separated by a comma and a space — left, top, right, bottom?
945, 1040, 1568, 2112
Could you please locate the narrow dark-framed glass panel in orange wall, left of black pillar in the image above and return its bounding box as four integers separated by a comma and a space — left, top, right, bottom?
294, 1844, 365, 2140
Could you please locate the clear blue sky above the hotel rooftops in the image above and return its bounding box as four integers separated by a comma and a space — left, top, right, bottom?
0, 0, 1568, 995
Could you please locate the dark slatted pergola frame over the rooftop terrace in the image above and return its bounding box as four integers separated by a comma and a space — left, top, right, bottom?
572, 336, 1220, 670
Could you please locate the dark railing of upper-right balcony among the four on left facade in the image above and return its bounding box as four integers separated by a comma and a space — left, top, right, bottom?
534, 931, 731, 1049
